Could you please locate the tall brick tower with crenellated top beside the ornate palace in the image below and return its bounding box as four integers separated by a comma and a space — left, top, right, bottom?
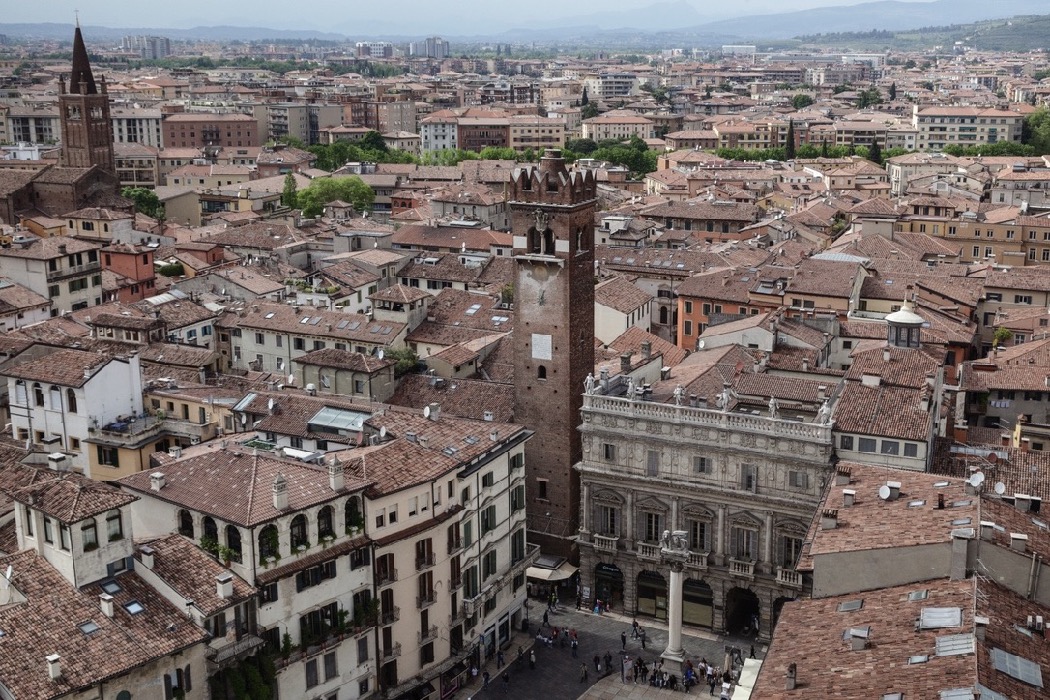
508, 150, 597, 561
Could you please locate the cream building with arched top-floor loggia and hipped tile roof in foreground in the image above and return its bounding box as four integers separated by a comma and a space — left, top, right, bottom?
120, 445, 376, 700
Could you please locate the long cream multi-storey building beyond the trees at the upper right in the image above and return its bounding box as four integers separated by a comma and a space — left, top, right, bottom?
911, 105, 1025, 151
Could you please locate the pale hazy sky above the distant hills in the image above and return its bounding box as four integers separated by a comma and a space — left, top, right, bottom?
18, 0, 936, 35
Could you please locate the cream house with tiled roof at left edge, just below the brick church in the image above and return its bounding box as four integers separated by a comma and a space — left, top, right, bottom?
0, 236, 102, 316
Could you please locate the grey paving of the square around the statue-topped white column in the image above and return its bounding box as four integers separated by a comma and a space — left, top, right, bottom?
458, 600, 765, 700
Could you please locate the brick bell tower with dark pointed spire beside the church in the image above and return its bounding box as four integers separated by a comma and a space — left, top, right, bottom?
59, 25, 117, 173
